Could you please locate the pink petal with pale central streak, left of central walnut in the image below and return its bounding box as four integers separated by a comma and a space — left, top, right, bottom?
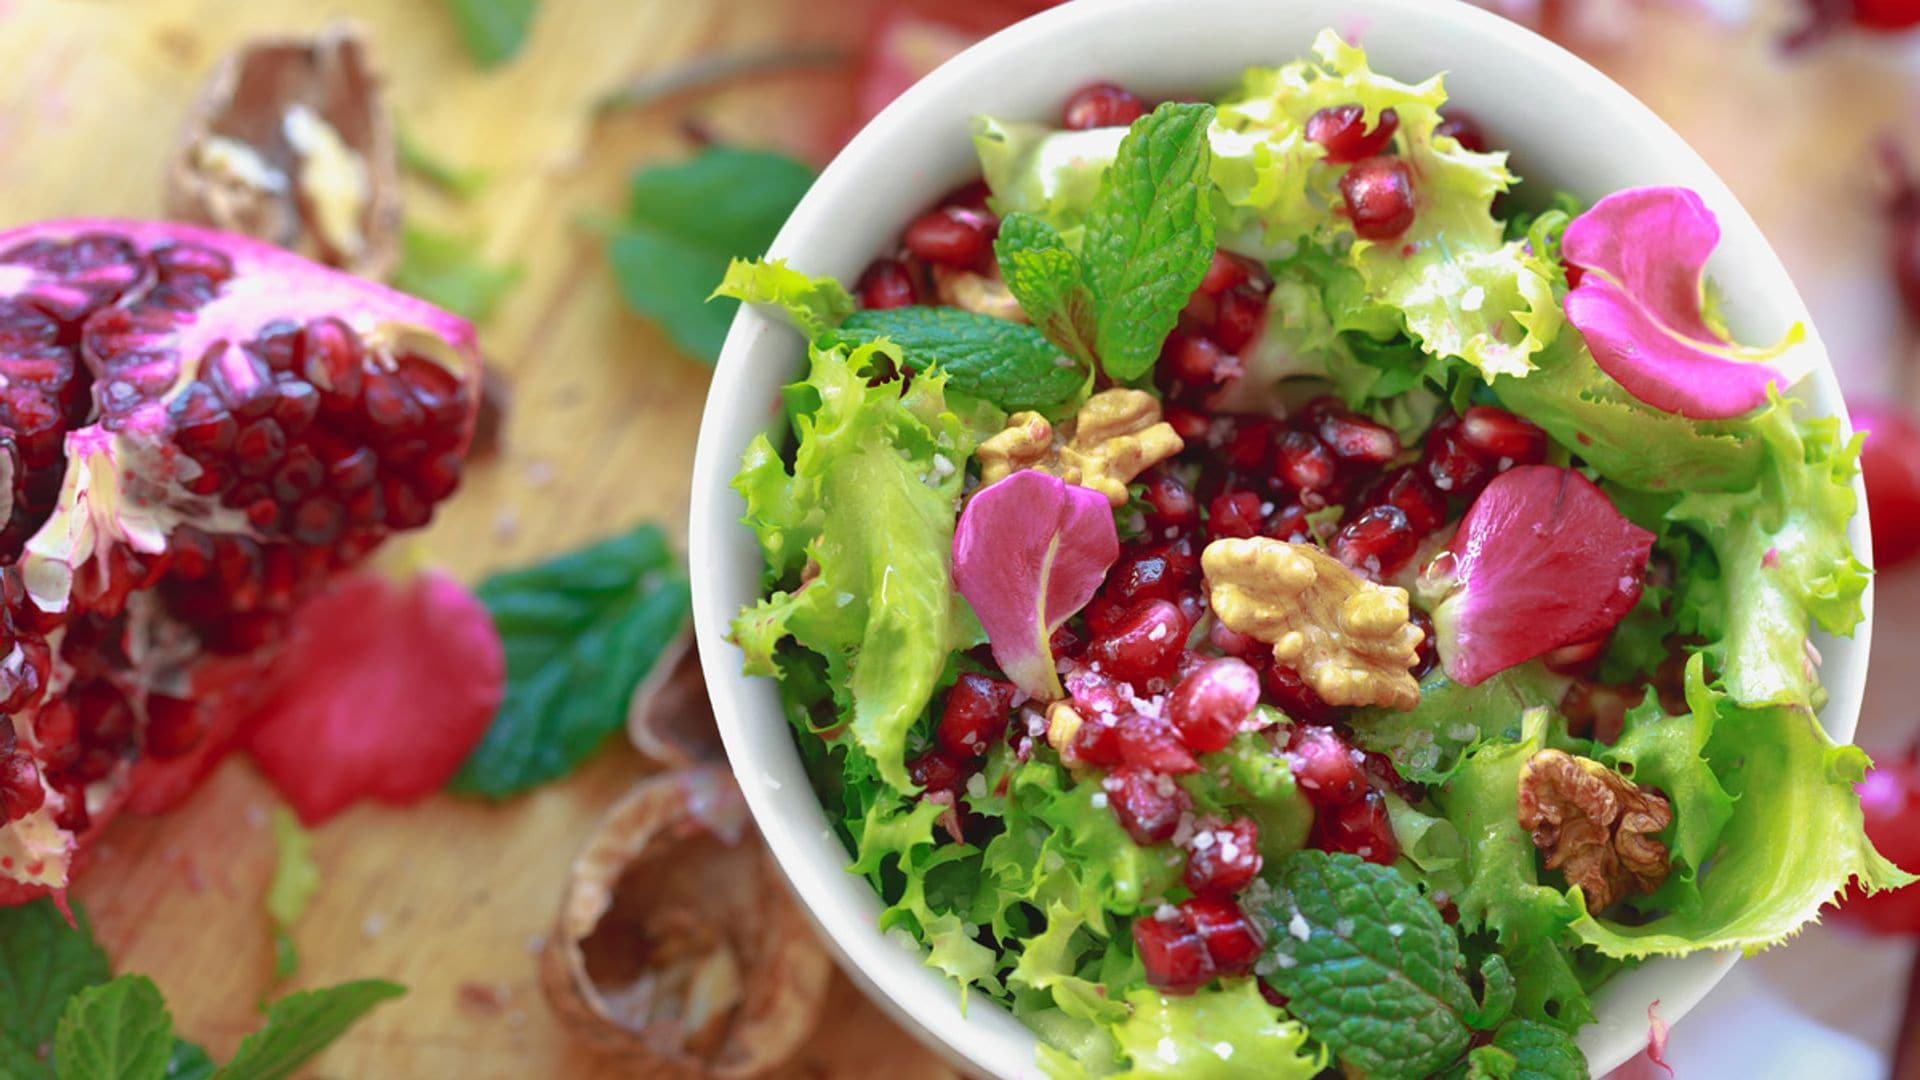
954, 469, 1119, 701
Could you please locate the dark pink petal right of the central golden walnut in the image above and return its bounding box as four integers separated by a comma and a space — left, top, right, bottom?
1423, 465, 1653, 686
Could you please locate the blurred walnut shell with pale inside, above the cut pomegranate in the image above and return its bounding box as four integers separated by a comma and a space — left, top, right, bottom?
167, 27, 399, 277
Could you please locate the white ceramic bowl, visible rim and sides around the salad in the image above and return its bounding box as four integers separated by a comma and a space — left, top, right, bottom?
689, 0, 1872, 1076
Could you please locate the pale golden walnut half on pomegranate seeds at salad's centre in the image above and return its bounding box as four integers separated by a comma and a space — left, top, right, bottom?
1200, 536, 1421, 709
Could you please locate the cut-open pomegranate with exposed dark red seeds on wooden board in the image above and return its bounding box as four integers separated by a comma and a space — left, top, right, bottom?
0, 219, 480, 903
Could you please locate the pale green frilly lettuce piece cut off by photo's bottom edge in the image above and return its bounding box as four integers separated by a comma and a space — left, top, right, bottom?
1114, 978, 1327, 1080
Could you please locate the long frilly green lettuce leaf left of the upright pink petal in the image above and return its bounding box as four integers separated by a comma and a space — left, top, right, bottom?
733, 344, 973, 792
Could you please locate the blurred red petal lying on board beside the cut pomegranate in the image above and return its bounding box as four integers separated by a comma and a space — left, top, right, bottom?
248, 571, 507, 826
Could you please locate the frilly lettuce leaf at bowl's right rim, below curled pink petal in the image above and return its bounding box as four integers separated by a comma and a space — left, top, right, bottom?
1667, 386, 1870, 709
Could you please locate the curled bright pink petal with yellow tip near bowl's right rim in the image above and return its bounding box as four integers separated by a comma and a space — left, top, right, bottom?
1561, 188, 1797, 419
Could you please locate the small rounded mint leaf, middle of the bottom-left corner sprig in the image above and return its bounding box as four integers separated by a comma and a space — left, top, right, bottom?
54, 974, 173, 1080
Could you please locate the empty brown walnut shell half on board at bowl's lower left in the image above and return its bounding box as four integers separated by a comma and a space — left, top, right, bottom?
541, 767, 833, 1080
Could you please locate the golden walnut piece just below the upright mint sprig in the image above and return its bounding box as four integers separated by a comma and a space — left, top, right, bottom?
979, 386, 1185, 505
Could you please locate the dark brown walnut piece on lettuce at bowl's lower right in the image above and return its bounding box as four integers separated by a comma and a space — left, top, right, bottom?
1519, 749, 1674, 911
